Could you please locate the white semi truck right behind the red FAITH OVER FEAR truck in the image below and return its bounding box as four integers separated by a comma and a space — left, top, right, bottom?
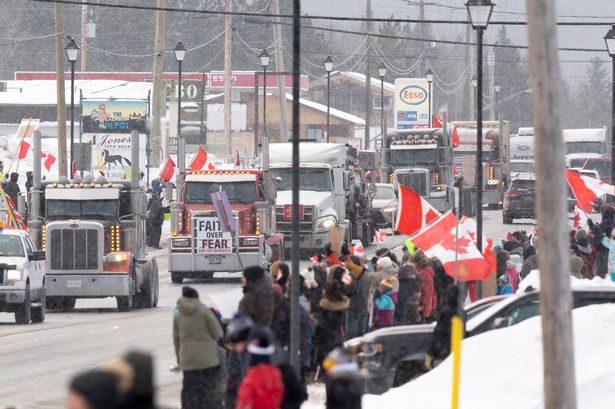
269, 143, 375, 253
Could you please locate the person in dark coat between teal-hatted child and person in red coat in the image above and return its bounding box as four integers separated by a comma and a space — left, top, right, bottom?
393, 264, 421, 325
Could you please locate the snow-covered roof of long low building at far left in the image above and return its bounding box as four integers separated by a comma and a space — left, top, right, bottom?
0, 80, 152, 105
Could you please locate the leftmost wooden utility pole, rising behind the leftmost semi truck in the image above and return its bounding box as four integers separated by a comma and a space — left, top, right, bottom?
55, 3, 68, 176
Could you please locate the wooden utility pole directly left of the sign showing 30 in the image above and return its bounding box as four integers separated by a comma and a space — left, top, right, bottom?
150, 0, 165, 168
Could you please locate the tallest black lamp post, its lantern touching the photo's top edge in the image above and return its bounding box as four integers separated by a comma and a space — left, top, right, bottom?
466, 0, 493, 298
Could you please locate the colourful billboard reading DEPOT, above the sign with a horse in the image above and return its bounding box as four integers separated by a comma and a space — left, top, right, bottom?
81, 99, 147, 134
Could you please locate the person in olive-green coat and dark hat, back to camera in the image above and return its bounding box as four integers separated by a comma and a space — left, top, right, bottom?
173, 286, 226, 409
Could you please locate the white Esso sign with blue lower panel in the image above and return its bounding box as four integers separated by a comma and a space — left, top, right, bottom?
394, 78, 431, 129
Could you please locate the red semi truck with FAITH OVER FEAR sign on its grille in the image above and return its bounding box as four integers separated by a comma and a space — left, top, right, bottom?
168, 169, 284, 283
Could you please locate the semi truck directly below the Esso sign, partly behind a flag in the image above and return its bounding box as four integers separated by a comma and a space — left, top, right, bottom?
381, 127, 455, 212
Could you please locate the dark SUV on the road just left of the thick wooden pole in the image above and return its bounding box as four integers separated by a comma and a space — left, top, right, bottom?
502, 176, 536, 224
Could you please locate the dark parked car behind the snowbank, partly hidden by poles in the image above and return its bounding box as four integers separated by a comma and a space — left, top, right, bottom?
354, 287, 615, 394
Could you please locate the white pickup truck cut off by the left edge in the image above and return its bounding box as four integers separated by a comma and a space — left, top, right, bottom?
0, 228, 45, 324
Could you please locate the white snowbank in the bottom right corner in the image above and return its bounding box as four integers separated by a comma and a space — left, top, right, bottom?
363, 304, 615, 409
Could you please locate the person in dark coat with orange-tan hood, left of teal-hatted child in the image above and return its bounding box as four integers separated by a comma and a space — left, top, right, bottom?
344, 256, 370, 339
